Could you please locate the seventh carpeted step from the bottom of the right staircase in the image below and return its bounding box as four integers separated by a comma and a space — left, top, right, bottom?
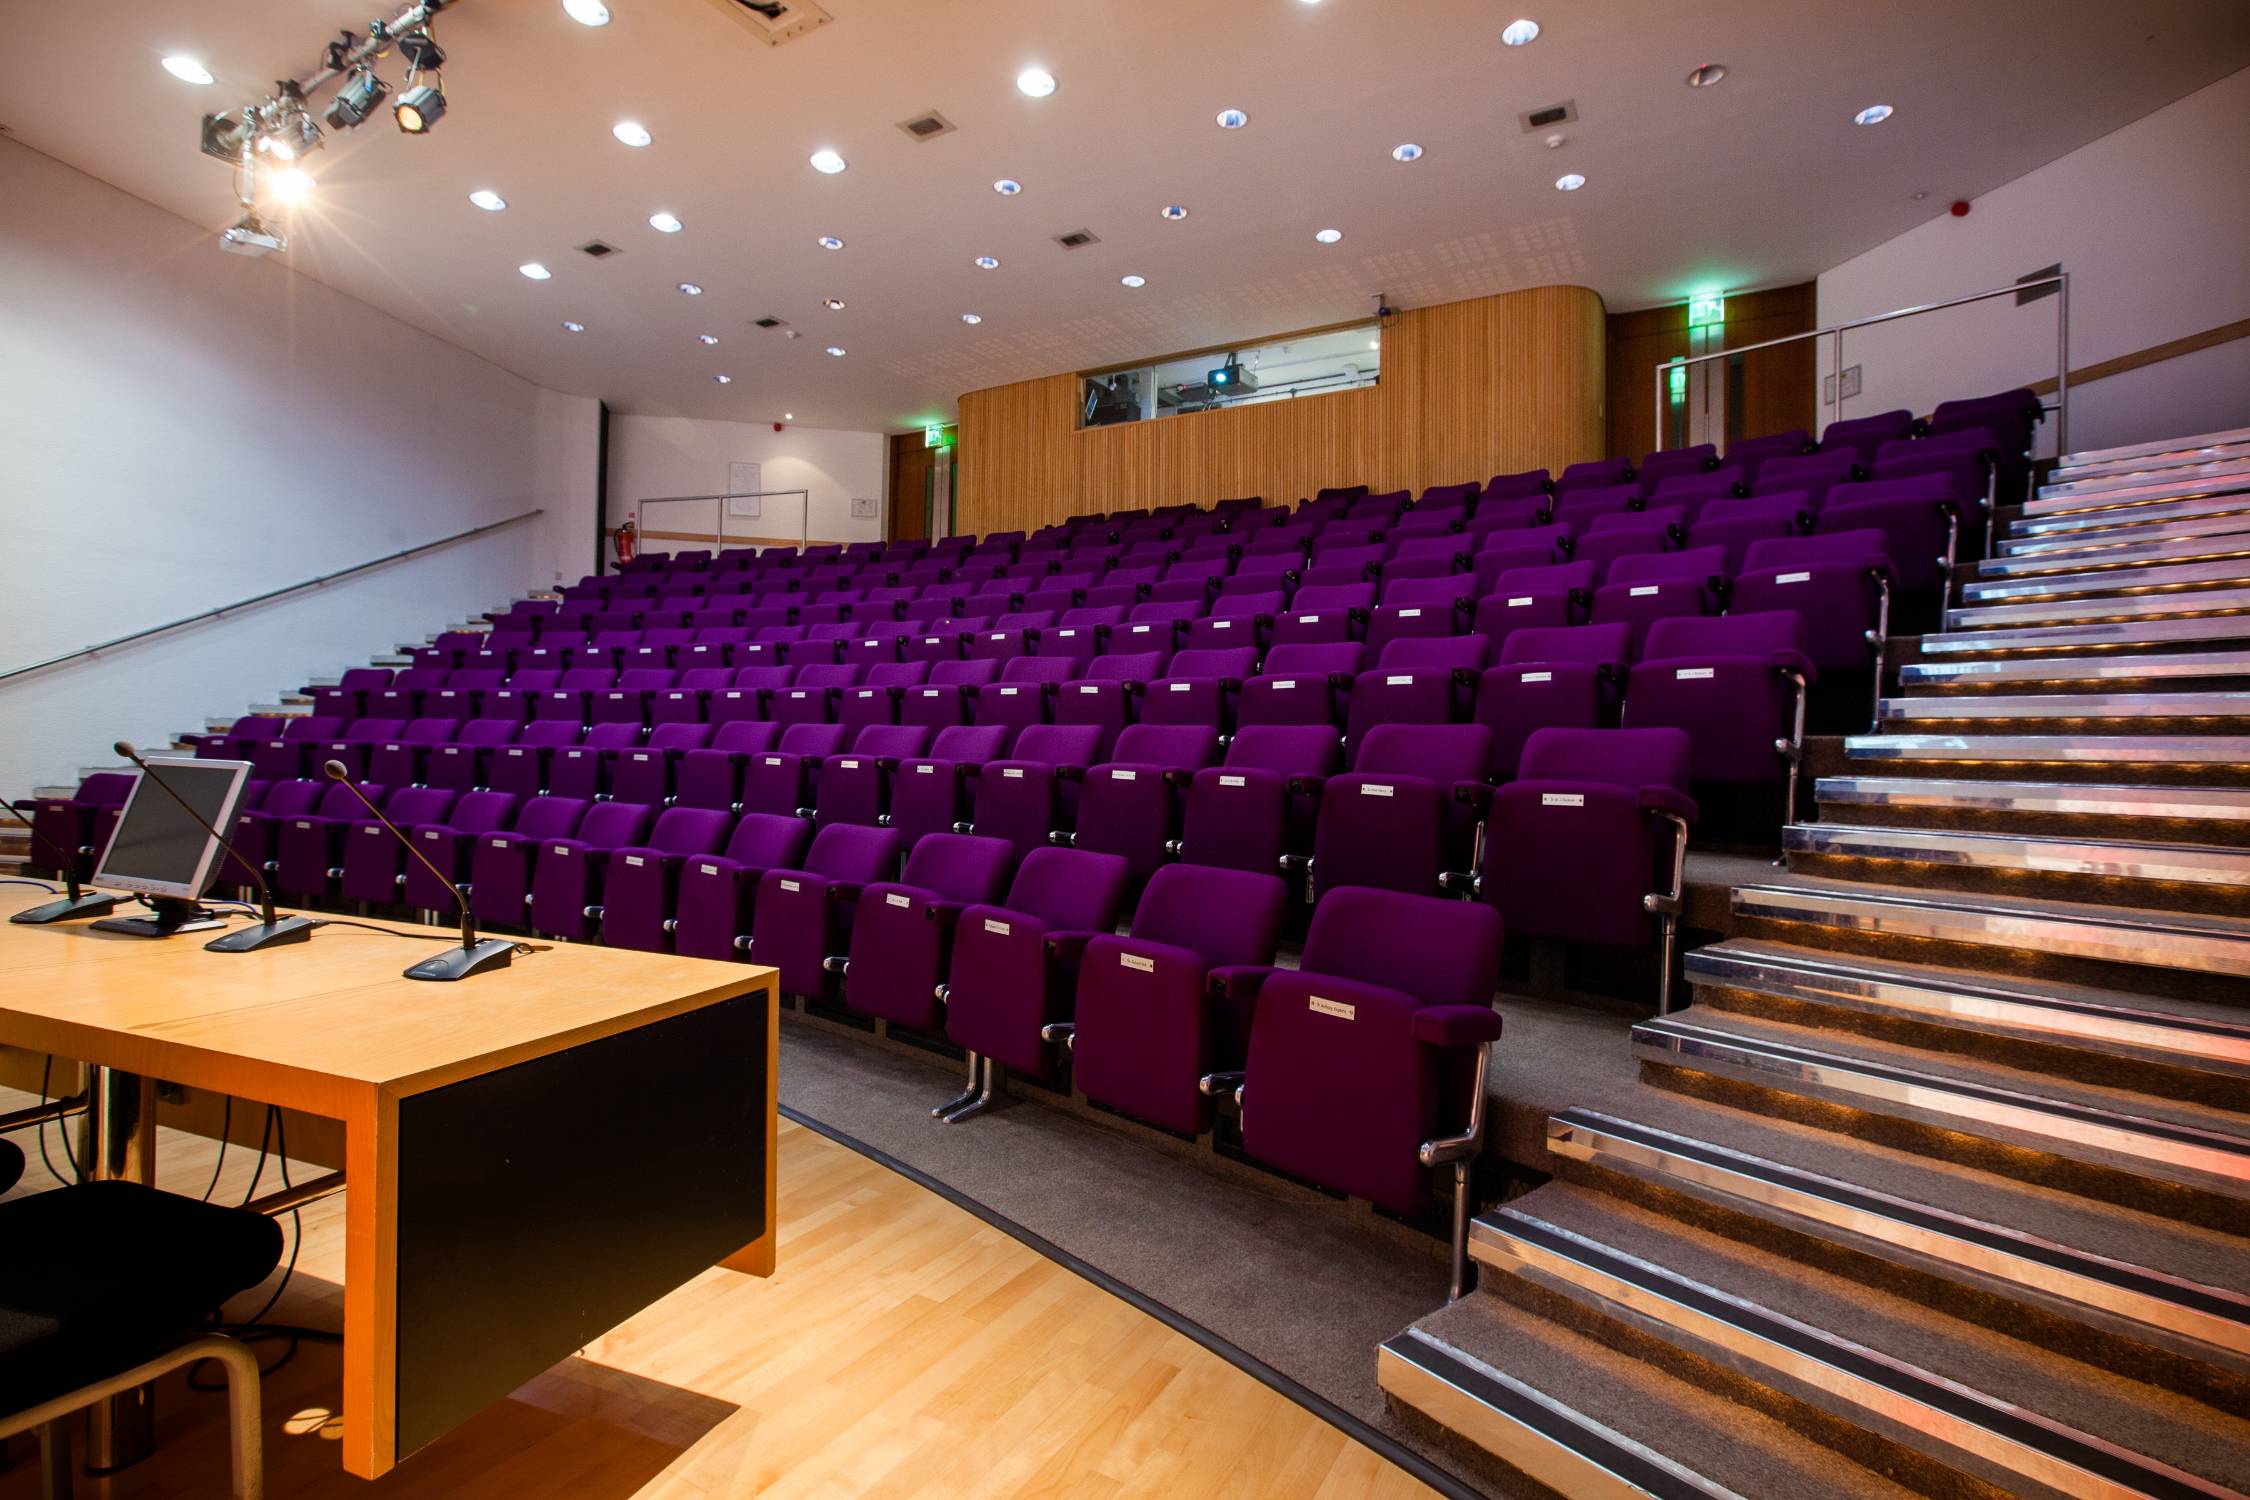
1782, 823, 2250, 918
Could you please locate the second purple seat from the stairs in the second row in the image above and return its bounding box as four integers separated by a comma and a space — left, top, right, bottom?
1312, 724, 1492, 902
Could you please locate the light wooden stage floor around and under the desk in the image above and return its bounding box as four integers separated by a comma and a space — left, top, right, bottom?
0, 1091, 1429, 1500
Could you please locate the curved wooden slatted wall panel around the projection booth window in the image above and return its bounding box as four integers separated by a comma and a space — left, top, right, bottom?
956, 286, 1604, 533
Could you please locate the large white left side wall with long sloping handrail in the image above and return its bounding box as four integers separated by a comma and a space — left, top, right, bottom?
0, 139, 596, 796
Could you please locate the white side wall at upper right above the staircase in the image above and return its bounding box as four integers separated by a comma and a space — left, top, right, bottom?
1820, 70, 2250, 452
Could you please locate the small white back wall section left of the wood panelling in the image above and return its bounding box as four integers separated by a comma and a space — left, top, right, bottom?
610, 414, 889, 551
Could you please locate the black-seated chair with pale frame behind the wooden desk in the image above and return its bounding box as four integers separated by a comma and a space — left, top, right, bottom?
0, 1178, 281, 1500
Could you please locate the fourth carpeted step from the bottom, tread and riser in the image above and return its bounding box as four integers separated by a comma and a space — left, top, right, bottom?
1634, 1005, 2250, 1235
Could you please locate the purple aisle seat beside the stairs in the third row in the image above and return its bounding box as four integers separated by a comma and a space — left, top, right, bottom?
1622, 609, 1814, 823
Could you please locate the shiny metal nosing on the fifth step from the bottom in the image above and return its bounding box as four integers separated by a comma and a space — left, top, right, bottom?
1688, 942, 2250, 1068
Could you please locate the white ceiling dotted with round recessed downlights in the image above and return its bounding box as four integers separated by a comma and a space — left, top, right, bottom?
0, 0, 2250, 430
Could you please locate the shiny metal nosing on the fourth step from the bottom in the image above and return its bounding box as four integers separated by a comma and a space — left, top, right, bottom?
1634, 1021, 2250, 1196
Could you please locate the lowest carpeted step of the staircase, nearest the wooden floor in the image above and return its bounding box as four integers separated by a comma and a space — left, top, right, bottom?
1377, 1298, 1913, 1500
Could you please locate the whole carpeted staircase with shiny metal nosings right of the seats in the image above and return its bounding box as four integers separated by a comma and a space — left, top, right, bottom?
1379, 432, 2250, 1500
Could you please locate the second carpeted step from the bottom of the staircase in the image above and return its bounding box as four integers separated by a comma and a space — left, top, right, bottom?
1472, 1183, 2250, 1500
